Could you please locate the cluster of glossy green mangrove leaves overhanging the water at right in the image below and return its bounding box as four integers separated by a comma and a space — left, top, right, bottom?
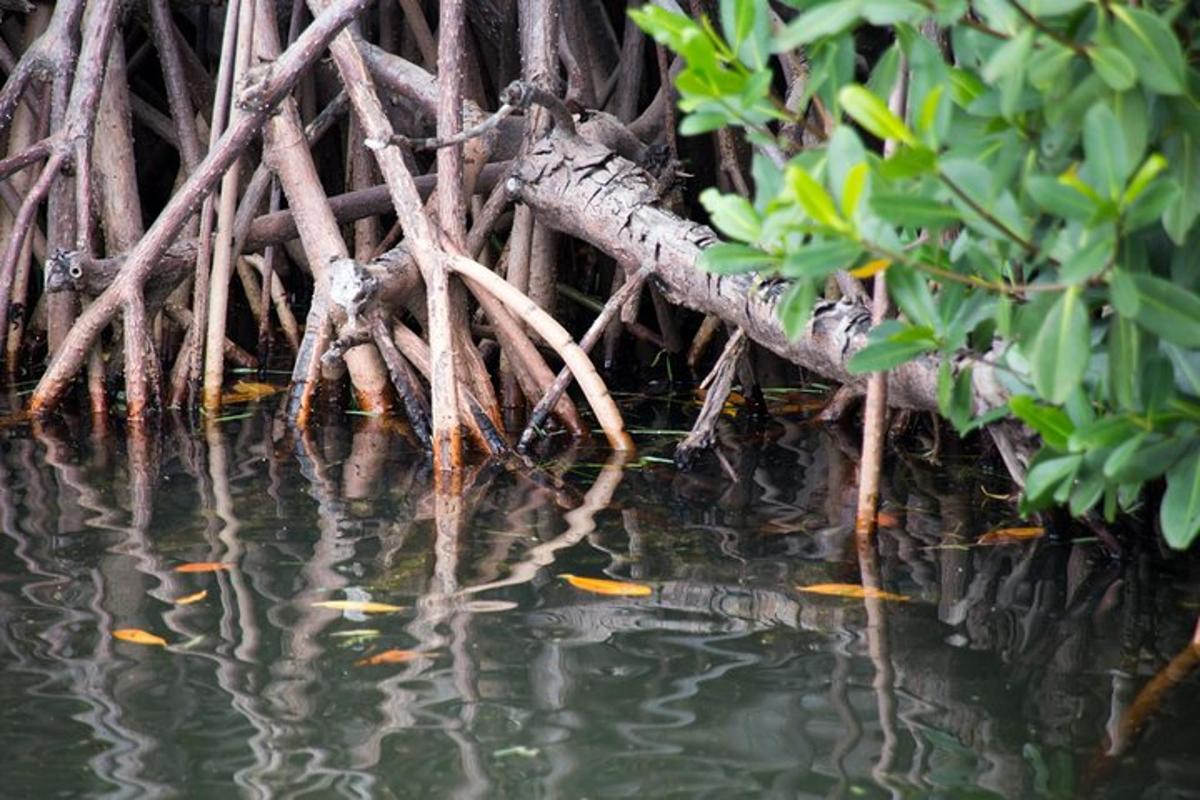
632, 0, 1200, 548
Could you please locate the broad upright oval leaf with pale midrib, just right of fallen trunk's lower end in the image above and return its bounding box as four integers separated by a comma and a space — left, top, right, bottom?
1030, 287, 1091, 405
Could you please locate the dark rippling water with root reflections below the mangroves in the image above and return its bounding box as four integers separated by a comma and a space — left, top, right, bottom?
0, 407, 1200, 798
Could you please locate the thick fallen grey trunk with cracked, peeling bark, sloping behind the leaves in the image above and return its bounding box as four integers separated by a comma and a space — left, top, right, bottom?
508, 125, 1007, 411
